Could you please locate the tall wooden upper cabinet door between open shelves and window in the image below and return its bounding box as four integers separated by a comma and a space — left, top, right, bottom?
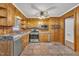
7, 4, 16, 26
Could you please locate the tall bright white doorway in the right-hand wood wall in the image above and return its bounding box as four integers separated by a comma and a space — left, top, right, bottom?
65, 17, 74, 49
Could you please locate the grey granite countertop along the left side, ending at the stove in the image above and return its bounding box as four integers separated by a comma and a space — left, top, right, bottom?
0, 31, 30, 41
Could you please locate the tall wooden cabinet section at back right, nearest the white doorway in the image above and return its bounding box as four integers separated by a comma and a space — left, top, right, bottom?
49, 17, 61, 42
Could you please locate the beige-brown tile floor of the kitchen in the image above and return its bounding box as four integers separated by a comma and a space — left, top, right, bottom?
21, 42, 77, 56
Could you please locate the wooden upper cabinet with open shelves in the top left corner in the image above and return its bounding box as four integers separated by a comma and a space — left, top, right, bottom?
0, 3, 16, 26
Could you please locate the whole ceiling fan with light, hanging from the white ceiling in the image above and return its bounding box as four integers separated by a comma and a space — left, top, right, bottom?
31, 4, 56, 19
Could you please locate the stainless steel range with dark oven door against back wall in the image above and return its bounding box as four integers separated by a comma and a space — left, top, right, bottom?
29, 29, 39, 43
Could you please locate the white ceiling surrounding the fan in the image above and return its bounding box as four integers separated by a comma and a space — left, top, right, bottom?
15, 3, 78, 17
